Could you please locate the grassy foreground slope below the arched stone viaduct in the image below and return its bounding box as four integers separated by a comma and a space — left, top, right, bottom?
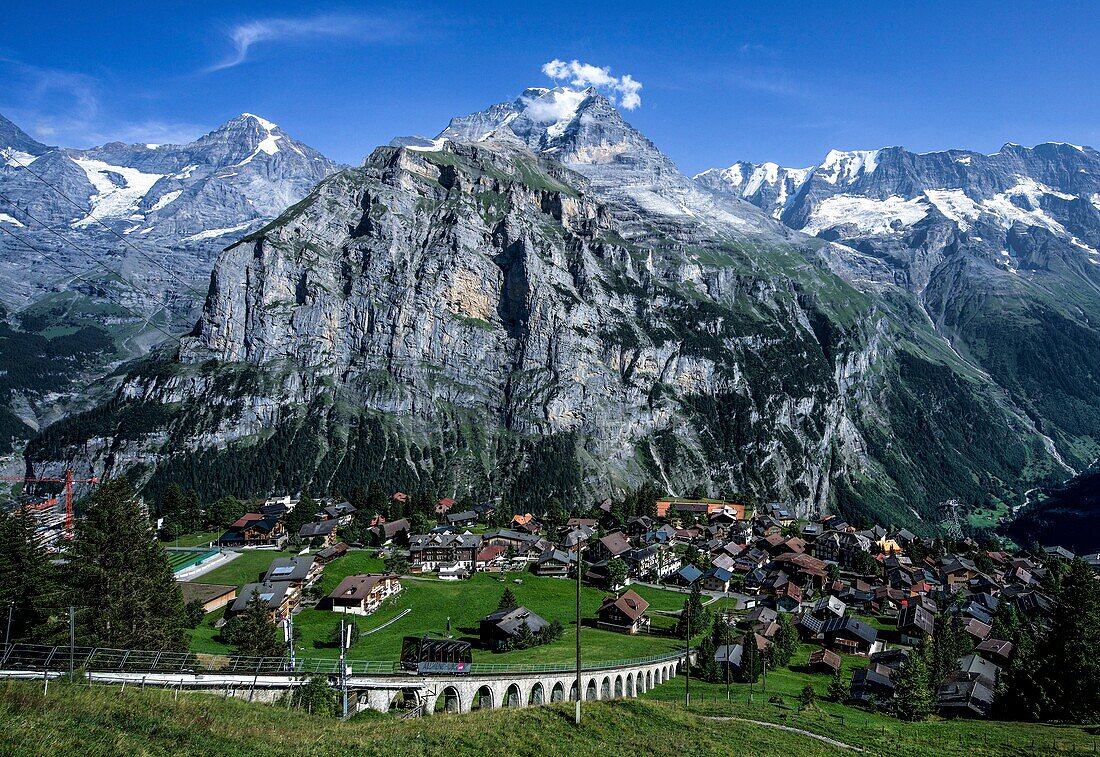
0, 679, 1093, 757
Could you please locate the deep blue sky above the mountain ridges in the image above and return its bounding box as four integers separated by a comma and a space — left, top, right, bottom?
0, 0, 1100, 173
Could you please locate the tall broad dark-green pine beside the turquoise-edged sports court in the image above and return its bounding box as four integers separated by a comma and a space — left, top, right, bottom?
67, 479, 187, 650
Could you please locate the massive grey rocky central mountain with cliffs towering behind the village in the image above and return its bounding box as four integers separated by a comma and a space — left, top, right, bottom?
28, 89, 1064, 523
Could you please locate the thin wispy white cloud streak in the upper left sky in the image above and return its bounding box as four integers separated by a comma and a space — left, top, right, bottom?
205, 15, 398, 74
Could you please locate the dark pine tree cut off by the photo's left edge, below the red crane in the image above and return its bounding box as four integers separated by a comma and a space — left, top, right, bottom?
0, 511, 57, 641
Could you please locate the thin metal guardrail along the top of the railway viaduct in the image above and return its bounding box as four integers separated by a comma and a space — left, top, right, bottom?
0, 644, 683, 676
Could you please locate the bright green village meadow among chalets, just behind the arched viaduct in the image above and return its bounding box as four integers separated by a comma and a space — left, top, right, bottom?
191, 551, 685, 663
